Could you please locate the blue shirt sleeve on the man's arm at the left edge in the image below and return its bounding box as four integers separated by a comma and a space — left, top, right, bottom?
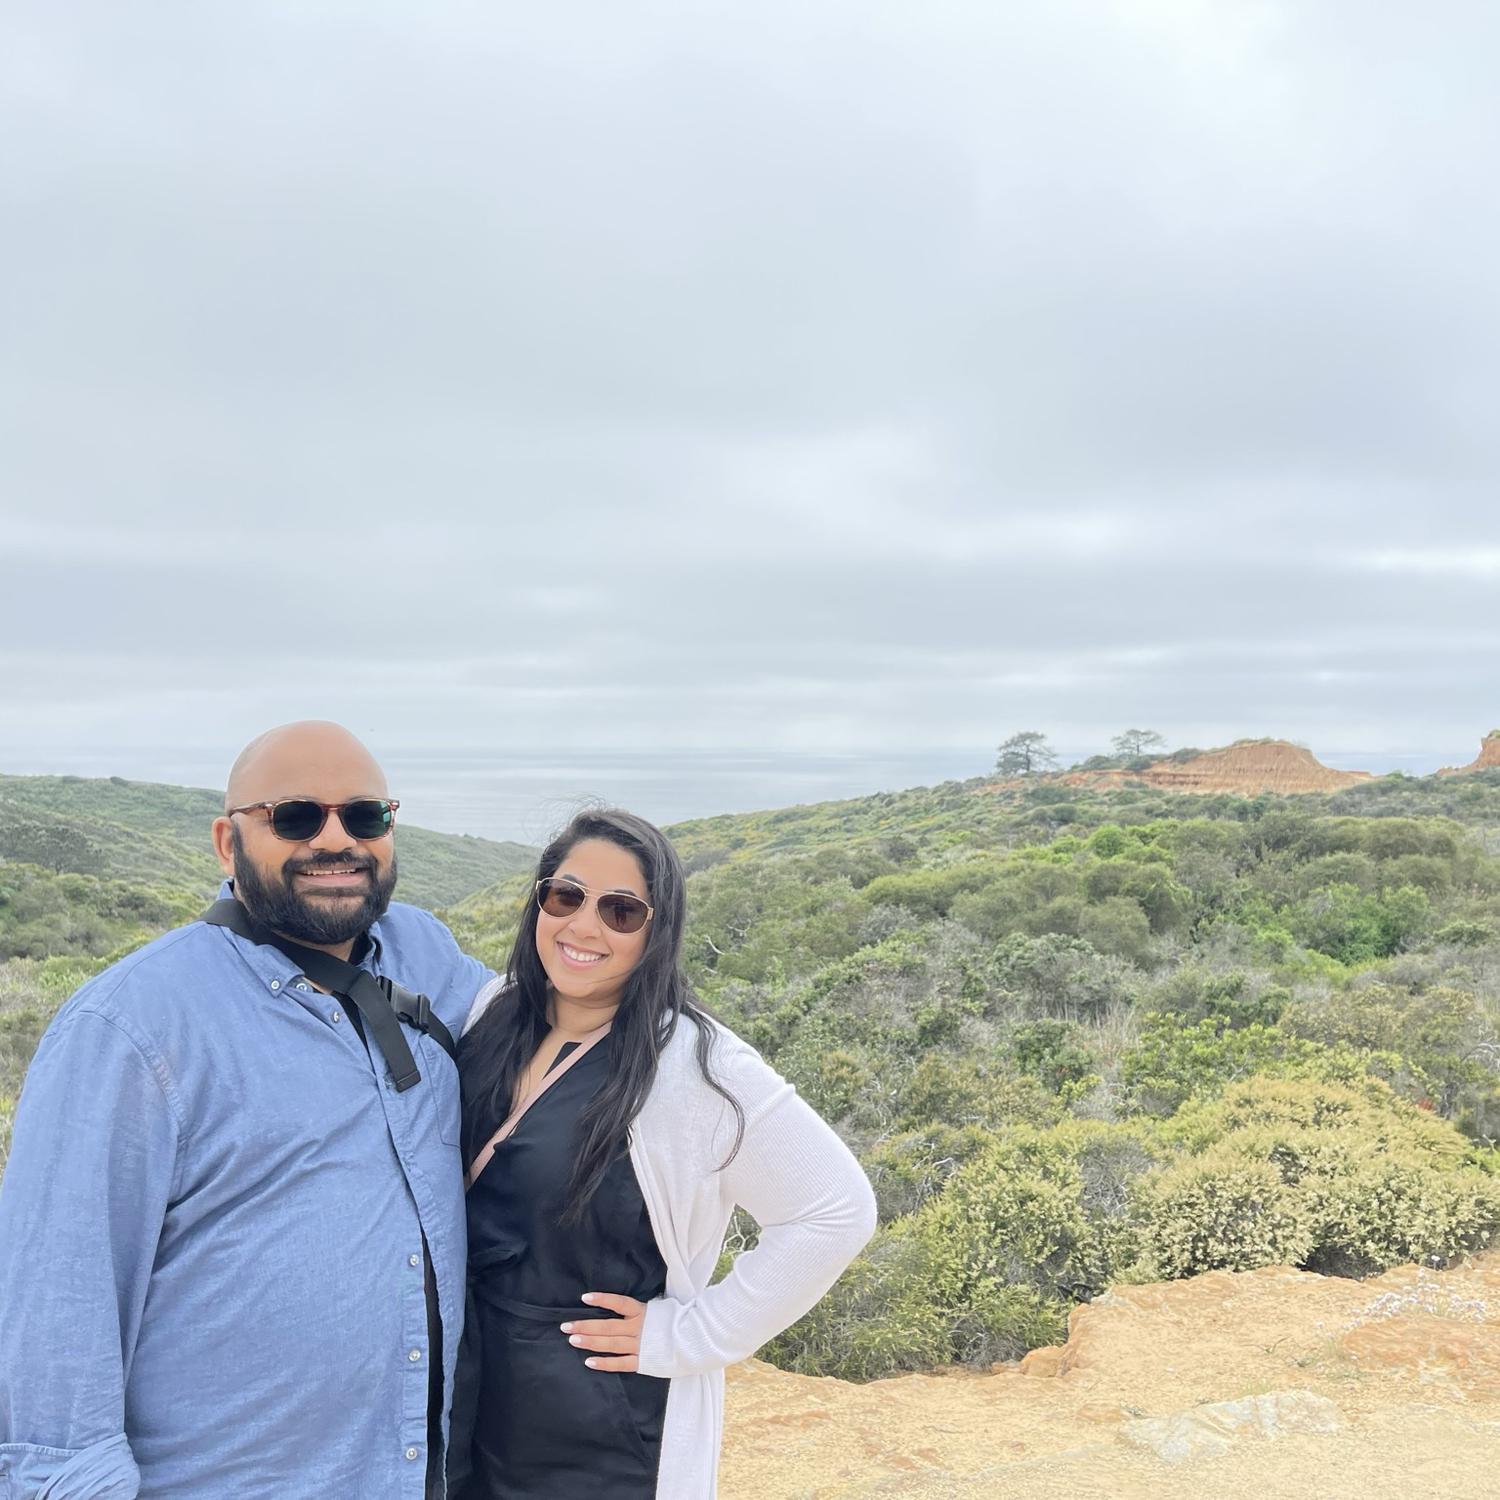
0, 1011, 182, 1500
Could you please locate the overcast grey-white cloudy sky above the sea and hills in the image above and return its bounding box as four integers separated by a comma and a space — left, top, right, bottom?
0, 0, 1500, 822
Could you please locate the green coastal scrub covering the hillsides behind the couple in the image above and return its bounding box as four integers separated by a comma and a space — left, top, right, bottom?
0, 756, 1500, 1379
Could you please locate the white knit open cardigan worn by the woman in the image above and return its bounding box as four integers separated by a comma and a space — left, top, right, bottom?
470, 996, 875, 1500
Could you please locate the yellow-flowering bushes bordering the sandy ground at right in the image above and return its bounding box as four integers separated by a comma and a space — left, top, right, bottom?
768, 1077, 1500, 1379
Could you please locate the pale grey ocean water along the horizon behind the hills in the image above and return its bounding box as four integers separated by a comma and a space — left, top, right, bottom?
0, 744, 1467, 845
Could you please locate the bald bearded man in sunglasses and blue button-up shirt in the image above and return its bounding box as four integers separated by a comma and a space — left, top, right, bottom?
0, 723, 492, 1500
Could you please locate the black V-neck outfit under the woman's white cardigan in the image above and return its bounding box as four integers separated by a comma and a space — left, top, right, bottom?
462, 1035, 668, 1500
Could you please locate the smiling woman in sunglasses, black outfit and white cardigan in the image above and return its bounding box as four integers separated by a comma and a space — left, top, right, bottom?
450, 810, 875, 1500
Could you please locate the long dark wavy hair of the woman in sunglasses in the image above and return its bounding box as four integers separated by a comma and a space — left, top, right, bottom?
459, 807, 746, 1223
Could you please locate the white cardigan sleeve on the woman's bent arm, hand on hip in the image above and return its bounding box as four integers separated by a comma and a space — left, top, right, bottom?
638, 1044, 875, 1377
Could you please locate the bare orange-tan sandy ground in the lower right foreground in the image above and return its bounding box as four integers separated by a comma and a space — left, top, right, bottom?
720, 1253, 1500, 1500
